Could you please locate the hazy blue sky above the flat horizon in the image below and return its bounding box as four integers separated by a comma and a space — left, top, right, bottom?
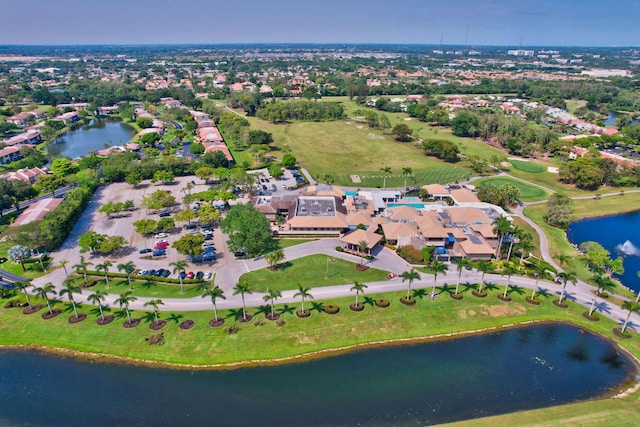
0, 0, 640, 47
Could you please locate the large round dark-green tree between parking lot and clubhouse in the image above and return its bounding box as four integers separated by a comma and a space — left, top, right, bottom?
221, 204, 273, 257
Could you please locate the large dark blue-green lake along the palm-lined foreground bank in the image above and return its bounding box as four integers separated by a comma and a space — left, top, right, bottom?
0, 324, 636, 426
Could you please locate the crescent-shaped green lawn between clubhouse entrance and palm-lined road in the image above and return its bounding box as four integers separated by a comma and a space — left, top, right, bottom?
238, 255, 389, 292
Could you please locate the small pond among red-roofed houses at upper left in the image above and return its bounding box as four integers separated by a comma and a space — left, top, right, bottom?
48, 118, 135, 159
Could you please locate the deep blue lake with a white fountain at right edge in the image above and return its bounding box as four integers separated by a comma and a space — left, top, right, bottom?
567, 211, 640, 291
